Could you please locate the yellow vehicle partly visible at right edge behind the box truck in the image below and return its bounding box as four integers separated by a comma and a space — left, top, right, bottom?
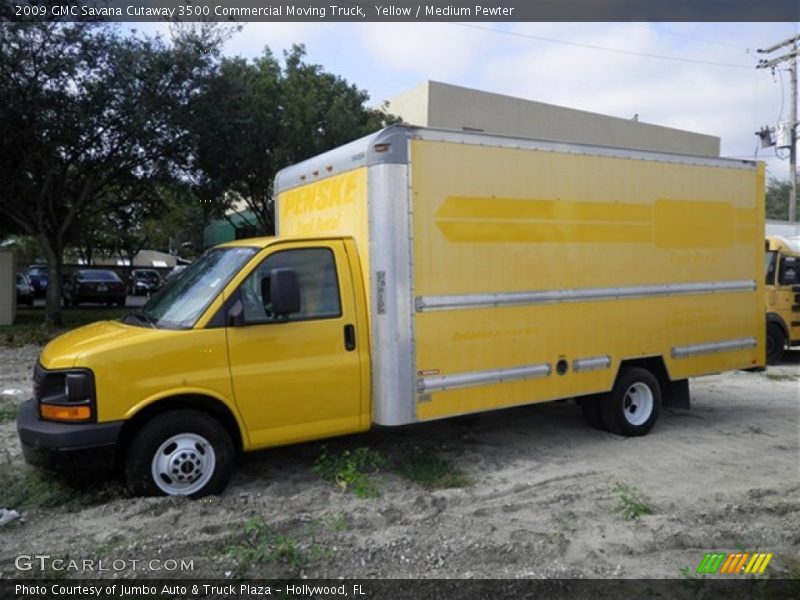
764, 236, 800, 365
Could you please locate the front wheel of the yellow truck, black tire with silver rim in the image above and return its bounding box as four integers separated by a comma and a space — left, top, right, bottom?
125, 410, 234, 498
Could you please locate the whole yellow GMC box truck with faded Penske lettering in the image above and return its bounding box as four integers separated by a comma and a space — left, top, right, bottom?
18, 126, 765, 497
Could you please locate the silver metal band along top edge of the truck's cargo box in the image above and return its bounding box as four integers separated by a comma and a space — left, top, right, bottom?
275, 123, 756, 195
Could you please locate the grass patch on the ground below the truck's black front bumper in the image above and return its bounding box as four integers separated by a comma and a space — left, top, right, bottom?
0, 459, 124, 512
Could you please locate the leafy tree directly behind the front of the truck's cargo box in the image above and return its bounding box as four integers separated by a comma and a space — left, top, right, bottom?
191, 45, 398, 235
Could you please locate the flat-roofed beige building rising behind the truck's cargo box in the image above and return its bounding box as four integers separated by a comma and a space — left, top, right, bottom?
388, 81, 720, 157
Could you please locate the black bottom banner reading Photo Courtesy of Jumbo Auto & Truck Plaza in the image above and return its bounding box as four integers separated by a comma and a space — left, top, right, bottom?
0, 575, 800, 600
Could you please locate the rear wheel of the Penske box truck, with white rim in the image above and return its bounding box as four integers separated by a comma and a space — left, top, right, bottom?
601, 367, 661, 437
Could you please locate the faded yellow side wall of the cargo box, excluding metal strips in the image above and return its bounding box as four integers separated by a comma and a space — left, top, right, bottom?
411, 140, 764, 420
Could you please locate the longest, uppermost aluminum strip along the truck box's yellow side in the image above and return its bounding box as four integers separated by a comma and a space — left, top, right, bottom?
415, 280, 756, 312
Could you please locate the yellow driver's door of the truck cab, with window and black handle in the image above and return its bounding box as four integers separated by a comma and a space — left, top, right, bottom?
226, 241, 366, 447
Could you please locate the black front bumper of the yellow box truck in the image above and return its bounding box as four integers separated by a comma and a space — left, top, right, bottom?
17, 400, 123, 473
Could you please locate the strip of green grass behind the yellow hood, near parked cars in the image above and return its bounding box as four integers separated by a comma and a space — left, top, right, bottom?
0, 307, 130, 348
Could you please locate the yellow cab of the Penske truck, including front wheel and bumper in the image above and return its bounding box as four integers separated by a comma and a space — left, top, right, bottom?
18, 238, 370, 497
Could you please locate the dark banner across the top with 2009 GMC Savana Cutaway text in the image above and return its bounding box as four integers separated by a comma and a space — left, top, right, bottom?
0, 0, 800, 22
